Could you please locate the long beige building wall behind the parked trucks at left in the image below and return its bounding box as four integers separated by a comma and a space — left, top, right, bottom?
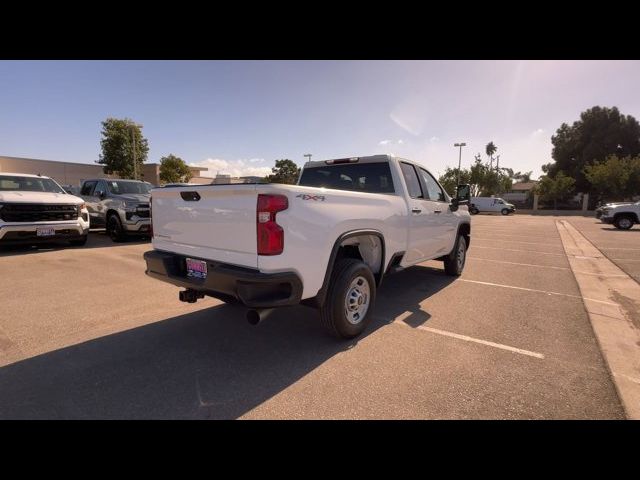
0, 156, 160, 186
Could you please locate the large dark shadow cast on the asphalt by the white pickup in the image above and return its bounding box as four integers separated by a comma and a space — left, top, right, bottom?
0, 267, 453, 419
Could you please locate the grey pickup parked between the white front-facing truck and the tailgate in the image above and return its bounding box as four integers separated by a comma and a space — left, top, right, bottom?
80, 178, 152, 242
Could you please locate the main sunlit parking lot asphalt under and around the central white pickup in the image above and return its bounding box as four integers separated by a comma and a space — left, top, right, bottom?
0, 219, 633, 419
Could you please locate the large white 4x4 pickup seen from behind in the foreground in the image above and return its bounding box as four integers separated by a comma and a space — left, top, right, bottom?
144, 155, 471, 338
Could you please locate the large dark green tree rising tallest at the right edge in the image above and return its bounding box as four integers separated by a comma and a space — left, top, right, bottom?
542, 106, 640, 193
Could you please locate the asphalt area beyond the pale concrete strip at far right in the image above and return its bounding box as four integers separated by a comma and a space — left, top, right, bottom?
571, 217, 640, 283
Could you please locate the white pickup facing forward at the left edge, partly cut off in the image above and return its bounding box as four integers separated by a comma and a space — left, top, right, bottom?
0, 173, 89, 246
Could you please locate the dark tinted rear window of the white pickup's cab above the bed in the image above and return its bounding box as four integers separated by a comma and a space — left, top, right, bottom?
298, 162, 395, 193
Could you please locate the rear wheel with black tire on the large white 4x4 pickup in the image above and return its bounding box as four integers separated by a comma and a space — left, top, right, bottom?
320, 258, 376, 339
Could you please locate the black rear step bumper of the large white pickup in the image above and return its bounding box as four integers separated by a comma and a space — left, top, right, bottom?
144, 250, 302, 308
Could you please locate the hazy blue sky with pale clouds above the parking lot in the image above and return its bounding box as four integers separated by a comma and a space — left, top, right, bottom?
0, 60, 640, 178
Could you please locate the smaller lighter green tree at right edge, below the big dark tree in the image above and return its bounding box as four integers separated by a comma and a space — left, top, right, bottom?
584, 155, 640, 200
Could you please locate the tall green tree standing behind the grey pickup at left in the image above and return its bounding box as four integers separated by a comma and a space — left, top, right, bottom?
96, 118, 149, 178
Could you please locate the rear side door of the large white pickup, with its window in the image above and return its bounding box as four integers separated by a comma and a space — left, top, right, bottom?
399, 162, 438, 266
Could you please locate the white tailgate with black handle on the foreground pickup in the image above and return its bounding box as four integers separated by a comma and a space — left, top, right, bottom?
151, 184, 258, 268
